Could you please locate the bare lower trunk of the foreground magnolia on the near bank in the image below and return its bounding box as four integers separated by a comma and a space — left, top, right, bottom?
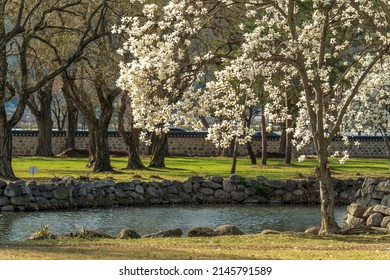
316, 150, 339, 234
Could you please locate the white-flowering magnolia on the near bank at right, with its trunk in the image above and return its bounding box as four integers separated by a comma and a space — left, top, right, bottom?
213, 0, 389, 233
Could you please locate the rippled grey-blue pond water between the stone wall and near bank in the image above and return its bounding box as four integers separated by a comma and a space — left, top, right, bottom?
0, 205, 346, 241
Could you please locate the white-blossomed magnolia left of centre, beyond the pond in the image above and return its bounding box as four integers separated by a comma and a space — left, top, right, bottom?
114, 0, 245, 167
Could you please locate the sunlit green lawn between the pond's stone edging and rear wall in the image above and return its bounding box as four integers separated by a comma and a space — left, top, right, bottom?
13, 154, 390, 182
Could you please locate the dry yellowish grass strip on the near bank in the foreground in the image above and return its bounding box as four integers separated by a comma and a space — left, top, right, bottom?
0, 234, 390, 260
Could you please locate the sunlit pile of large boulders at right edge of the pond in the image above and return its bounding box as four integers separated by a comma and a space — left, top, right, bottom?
344, 178, 390, 229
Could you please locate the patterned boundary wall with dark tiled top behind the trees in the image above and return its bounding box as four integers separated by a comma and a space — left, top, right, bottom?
13, 131, 387, 158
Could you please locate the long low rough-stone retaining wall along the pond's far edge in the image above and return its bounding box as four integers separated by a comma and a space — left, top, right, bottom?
0, 175, 362, 211
